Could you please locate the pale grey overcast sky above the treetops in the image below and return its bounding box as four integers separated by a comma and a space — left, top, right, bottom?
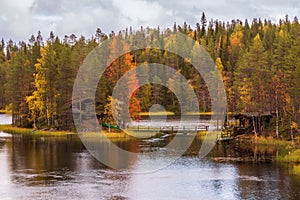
0, 0, 300, 41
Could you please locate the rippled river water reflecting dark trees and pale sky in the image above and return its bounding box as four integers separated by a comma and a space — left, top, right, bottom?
0, 115, 300, 200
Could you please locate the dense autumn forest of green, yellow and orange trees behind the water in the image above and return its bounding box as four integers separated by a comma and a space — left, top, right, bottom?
0, 13, 300, 134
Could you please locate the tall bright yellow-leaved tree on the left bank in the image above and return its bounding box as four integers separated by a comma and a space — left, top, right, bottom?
27, 39, 60, 127
